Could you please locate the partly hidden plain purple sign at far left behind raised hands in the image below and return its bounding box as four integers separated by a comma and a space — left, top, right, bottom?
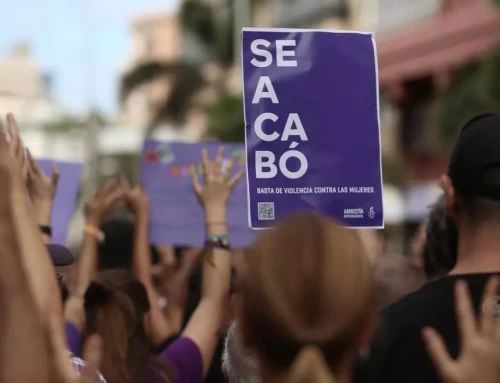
37, 159, 83, 245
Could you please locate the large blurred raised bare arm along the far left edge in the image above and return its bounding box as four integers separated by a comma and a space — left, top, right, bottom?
0, 124, 49, 383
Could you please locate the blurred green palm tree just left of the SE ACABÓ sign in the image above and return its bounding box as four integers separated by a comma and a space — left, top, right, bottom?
120, 0, 261, 140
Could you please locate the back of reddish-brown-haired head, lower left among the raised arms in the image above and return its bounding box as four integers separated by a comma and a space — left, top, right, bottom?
85, 270, 171, 383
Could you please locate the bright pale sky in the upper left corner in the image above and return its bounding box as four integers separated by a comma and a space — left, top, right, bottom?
0, 0, 178, 113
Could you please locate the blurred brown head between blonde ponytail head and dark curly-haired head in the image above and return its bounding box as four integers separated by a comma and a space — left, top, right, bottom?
373, 255, 425, 309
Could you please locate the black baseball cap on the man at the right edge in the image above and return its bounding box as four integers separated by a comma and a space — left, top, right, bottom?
448, 113, 500, 201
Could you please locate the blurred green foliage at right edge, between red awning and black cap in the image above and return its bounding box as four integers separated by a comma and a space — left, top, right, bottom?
438, 49, 500, 148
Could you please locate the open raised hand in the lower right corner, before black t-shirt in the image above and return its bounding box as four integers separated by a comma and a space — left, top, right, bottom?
422, 277, 500, 383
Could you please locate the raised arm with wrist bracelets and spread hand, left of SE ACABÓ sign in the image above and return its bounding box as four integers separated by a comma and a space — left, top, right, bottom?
183, 148, 243, 375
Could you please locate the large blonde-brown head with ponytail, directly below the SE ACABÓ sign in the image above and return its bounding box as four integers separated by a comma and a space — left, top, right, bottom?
240, 213, 376, 382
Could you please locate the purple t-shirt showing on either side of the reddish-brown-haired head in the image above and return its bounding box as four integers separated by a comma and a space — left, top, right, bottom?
66, 321, 203, 383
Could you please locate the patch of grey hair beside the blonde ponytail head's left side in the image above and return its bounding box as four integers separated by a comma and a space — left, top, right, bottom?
222, 321, 261, 383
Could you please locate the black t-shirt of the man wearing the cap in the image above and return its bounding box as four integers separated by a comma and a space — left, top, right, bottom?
353, 274, 494, 383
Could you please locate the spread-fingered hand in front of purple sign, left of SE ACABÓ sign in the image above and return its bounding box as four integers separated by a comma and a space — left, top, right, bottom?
190, 147, 244, 210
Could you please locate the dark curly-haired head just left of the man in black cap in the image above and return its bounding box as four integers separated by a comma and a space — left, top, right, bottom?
422, 196, 458, 280
